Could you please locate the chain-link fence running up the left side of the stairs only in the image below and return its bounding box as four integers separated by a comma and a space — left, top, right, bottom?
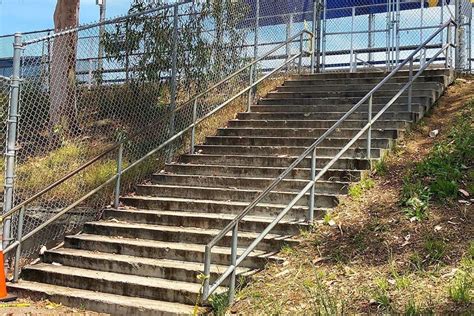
0, 0, 311, 257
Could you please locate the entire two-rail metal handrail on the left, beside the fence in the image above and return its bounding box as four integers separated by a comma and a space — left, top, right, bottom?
0, 30, 313, 282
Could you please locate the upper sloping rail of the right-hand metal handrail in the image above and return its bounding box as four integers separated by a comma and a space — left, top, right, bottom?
206, 19, 456, 248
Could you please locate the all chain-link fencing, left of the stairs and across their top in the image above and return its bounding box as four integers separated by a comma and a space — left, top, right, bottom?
0, 0, 472, 262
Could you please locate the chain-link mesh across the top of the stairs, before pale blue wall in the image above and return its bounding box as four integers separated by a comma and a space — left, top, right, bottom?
321, 0, 471, 71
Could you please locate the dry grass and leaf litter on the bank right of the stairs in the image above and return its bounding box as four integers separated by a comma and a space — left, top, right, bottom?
231, 76, 474, 315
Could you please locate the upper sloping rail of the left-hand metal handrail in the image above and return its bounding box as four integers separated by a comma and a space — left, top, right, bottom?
0, 30, 313, 222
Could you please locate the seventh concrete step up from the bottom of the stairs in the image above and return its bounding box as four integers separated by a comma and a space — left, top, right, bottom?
120, 195, 328, 220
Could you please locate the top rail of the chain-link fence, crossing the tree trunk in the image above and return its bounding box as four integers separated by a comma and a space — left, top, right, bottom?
23, 0, 194, 46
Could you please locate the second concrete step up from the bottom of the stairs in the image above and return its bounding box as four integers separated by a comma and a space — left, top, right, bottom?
22, 263, 224, 305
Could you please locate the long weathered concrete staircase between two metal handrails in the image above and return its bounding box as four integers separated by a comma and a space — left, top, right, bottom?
10, 69, 452, 315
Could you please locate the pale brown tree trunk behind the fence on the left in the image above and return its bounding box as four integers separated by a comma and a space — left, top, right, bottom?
49, 0, 80, 140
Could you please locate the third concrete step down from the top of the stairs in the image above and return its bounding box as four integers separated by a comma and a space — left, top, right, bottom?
276, 82, 444, 93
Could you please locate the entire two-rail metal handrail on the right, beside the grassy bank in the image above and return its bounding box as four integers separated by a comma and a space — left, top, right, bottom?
202, 20, 456, 301
